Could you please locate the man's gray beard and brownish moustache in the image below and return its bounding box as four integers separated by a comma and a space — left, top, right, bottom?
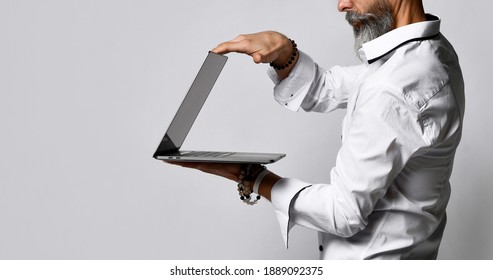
346, 0, 394, 59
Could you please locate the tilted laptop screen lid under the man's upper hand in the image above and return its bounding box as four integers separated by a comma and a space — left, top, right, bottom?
155, 52, 228, 156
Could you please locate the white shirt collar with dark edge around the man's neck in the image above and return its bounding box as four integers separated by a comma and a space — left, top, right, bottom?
359, 14, 441, 63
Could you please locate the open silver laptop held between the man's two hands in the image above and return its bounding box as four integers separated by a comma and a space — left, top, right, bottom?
153, 52, 286, 164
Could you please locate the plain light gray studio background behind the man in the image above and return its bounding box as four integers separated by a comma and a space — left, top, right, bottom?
0, 0, 493, 259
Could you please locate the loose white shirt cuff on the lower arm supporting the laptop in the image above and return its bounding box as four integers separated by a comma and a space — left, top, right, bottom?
271, 178, 310, 248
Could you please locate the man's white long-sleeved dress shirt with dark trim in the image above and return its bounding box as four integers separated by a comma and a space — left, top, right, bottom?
269, 15, 464, 259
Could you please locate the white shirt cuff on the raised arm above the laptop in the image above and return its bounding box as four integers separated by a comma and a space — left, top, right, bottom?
267, 51, 316, 111
